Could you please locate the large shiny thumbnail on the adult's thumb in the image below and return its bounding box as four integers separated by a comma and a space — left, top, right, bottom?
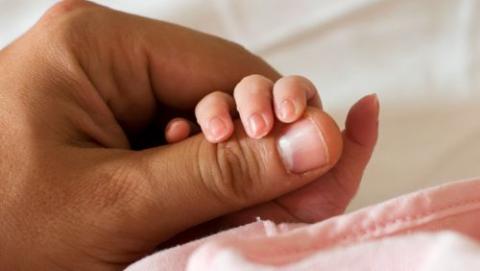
277, 118, 329, 173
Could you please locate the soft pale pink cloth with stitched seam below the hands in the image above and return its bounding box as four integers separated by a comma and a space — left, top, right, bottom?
127, 179, 480, 271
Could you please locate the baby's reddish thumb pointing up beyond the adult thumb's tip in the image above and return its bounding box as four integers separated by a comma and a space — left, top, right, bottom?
276, 95, 379, 222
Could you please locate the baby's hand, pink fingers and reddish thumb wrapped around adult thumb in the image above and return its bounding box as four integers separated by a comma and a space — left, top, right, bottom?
165, 75, 379, 242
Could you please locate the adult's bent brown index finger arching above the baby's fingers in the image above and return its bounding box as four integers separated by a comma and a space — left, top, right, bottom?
38, 1, 279, 135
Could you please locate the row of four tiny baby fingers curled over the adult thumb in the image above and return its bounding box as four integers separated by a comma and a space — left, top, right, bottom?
166, 75, 321, 143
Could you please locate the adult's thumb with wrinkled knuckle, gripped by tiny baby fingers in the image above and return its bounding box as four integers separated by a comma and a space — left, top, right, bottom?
122, 108, 342, 241
